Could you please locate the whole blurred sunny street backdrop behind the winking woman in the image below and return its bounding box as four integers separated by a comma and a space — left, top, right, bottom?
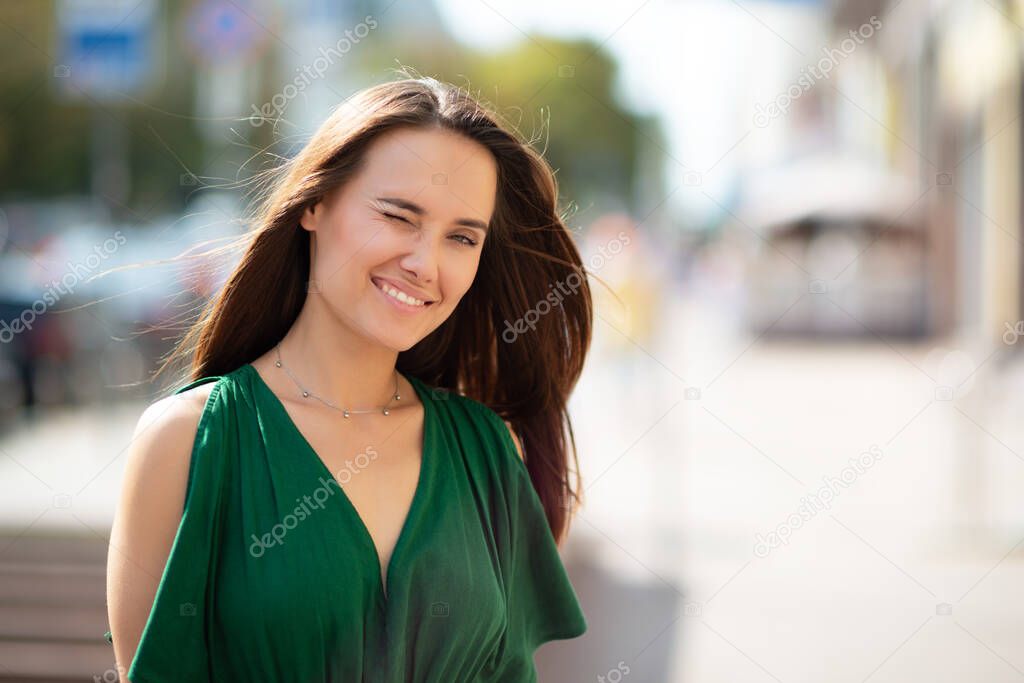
0, 0, 1024, 683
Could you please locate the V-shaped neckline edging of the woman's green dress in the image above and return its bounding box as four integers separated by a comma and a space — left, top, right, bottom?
246, 362, 434, 603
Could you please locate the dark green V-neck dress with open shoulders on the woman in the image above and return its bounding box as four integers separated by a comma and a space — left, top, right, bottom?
104, 364, 587, 683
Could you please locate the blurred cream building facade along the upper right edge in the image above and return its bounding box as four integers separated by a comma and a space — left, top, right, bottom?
830, 0, 1024, 343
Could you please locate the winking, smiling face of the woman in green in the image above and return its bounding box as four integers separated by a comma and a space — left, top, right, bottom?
301, 128, 498, 351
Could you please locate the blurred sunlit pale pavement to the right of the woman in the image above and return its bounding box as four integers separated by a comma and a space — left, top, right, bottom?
551, 280, 1024, 682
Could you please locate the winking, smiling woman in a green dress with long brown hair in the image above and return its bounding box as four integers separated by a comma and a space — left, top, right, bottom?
108, 79, 592, 683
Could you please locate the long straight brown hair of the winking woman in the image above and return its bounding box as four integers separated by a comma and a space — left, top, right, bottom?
157, 78, 593, 542
